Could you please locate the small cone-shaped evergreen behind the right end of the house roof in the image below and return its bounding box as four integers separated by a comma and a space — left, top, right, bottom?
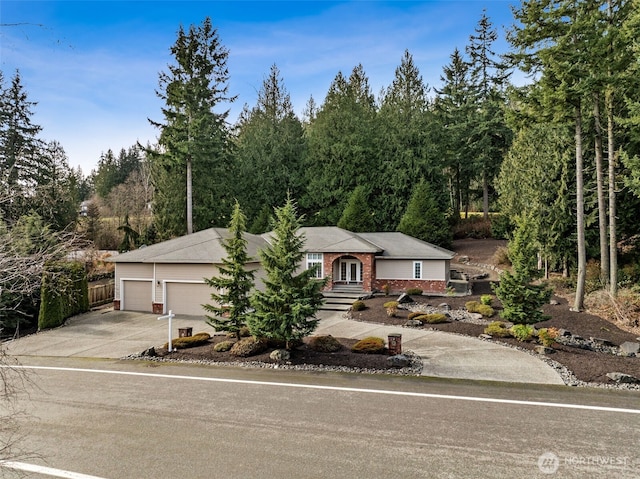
398, 180, 452, 248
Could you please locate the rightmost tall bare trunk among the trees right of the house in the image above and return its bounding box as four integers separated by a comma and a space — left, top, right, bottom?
605, 91, 618, 298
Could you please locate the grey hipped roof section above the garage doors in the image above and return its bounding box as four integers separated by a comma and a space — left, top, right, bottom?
111, 228, 266, 264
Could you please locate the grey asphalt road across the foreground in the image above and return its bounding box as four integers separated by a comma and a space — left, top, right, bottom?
5, 358, 640, 479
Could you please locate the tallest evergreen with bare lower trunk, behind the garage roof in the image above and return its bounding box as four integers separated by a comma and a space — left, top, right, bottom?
148, 18, 234, 235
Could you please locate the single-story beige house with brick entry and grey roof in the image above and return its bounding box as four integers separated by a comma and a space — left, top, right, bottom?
111, 226, 455, 315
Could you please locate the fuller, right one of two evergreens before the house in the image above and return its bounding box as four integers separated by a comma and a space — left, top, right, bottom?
248, 198, 325, 349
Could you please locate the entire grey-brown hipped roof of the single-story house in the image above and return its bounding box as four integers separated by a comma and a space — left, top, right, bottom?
110, 226, 455, 264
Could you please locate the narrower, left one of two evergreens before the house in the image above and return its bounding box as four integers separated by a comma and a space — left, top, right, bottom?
202, 201, 254, 339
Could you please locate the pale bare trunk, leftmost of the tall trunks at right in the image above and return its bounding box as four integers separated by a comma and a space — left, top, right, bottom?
572, 102, 587, 312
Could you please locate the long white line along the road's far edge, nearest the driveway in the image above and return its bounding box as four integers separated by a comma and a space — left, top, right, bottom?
6, 365, 640, 414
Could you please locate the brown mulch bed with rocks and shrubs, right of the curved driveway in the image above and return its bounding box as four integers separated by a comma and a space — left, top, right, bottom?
352, 288, 640, 384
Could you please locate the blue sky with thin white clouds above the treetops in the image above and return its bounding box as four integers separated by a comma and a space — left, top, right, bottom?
0, 0, 514, 175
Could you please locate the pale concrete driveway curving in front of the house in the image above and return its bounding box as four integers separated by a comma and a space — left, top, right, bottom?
4, 309, 564, 384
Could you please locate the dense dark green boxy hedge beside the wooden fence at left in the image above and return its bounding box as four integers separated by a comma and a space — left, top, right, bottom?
38, 262, 89, 330
